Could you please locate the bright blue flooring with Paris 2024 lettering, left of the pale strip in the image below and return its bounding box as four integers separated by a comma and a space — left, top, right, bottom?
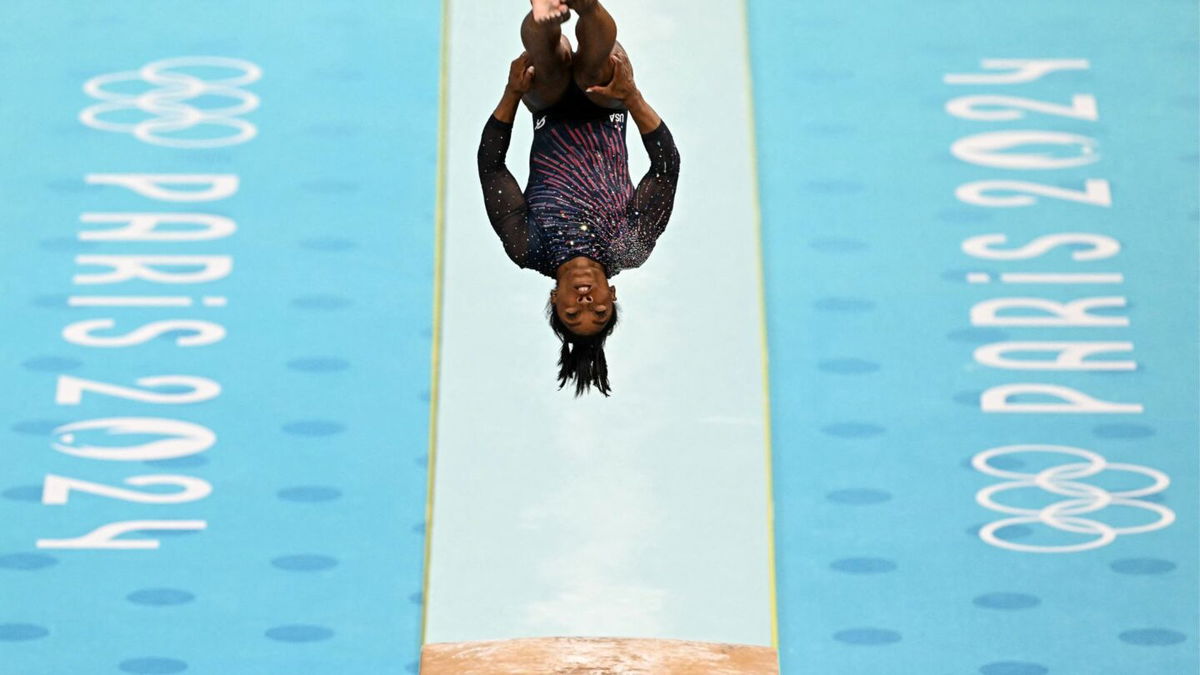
0, 0, 440, 675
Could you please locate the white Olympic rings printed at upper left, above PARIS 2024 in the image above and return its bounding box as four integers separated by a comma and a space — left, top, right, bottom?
79, 56, 263, 148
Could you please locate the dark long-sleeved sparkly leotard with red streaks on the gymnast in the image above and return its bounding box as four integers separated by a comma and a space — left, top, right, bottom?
478, 84, 679, 277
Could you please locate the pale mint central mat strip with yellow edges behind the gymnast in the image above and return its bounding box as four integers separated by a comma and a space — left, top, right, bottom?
426, 0, 774, 645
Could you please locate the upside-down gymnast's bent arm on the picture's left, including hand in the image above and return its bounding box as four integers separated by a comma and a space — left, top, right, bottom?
476, 53, 534, 267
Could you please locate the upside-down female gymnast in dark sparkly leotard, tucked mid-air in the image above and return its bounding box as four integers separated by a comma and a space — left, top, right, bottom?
478, 0, 679, 396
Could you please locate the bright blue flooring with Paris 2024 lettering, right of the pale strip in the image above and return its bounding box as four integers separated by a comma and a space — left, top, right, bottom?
751, 0, 1198, 675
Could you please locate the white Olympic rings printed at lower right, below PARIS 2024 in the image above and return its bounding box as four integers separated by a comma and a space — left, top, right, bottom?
971, 446, 1175, 554
